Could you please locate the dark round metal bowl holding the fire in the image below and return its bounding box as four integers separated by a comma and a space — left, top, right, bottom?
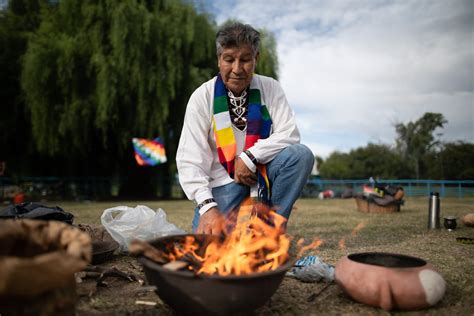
138, 235, 293, 315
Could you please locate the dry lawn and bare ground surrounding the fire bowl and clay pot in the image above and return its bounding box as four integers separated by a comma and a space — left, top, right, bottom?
64, 198, 474, 315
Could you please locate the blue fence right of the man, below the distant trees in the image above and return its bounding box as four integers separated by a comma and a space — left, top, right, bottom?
303, 178, 474, 198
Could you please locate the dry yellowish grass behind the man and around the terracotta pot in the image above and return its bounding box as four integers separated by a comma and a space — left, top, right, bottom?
64, 198, 474, 315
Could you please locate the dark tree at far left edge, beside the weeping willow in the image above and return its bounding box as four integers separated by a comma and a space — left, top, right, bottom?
0, 0, 46, 176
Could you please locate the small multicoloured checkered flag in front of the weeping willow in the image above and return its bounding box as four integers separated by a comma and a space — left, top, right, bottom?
132, 137, 166, 166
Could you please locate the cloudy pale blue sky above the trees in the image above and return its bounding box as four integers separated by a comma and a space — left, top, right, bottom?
197, 0, 474, 158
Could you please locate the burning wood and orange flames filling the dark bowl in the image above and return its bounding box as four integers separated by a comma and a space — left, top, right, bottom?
130, 200, 292, 276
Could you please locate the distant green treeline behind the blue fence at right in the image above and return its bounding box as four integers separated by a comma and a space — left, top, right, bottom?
318, 113, 474, 180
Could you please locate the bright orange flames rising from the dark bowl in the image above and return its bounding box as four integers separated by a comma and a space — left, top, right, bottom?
164, 200, 290, 276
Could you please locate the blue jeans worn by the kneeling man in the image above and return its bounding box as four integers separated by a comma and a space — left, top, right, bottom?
193, 144, 314, 232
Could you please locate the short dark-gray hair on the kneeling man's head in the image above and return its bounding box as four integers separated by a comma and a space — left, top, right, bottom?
216, 22, 260, 56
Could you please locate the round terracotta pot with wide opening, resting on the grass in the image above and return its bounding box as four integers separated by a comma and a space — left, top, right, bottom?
335, 252, 446, 311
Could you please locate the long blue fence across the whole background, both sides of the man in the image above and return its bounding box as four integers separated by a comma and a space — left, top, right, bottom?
0, 177, 474, 201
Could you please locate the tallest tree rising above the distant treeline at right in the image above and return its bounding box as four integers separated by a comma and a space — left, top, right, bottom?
395, 112, 448, 179
